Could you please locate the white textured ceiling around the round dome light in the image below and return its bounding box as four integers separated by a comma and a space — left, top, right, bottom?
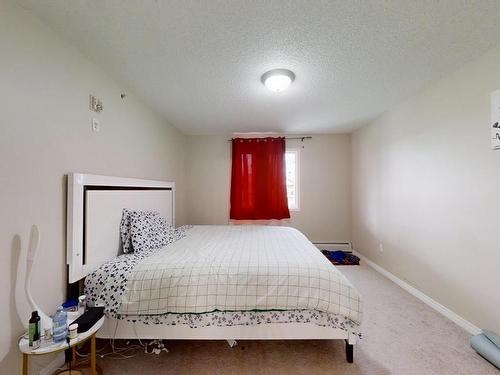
19, 0, 500, 134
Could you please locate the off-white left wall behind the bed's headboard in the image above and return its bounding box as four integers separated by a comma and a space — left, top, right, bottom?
0, 2, 186, 374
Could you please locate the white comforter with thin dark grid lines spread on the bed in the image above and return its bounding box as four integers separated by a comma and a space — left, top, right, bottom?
120, 225, 362, 323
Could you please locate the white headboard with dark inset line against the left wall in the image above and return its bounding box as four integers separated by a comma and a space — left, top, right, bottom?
66, 173, 175, 283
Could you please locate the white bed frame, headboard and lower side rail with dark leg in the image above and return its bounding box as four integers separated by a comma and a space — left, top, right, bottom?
67, 173, 356, 363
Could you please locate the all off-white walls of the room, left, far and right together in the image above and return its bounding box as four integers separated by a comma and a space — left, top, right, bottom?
4, 2, 500, 374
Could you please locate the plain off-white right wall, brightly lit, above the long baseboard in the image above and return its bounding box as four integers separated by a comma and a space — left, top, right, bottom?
352, 47, 500, 332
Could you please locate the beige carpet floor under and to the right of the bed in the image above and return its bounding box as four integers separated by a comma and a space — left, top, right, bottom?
91, 266, 500, 375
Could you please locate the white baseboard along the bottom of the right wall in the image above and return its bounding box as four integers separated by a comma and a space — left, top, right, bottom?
354, 251, 481, 335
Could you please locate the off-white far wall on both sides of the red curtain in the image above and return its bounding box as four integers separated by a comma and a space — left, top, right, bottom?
186, 134, 351, 241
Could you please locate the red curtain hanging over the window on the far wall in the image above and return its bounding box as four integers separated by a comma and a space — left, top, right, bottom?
230, 137, 290, 220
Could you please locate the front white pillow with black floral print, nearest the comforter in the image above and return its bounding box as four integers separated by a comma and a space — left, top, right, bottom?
129, 211, 176, 251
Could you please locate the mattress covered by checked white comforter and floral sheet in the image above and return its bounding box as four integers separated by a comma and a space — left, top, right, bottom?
86, 225, 362, 328
